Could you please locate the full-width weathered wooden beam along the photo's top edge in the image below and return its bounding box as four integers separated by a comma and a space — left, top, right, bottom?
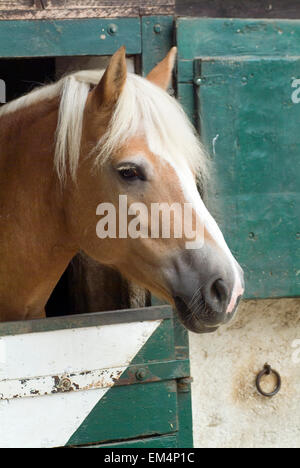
0, 0, 300, 19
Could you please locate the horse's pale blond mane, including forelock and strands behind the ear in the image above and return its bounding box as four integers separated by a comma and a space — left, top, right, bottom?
0, 70, 208, 183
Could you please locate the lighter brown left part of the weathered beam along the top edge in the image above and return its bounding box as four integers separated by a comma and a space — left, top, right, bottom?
0, 0, 175, 20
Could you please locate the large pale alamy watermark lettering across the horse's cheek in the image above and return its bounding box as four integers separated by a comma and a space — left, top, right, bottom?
96, 195, 205, 249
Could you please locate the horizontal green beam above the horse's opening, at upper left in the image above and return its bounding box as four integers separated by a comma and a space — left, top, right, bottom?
0, 18, 142, 57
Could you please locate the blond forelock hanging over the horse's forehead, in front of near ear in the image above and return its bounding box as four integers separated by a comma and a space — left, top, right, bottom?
96, 74, 208, 179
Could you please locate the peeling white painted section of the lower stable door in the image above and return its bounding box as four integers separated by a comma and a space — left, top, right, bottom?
0, 320, 161, 448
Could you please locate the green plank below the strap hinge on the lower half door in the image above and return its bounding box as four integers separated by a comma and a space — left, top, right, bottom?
67, 381, 178, 445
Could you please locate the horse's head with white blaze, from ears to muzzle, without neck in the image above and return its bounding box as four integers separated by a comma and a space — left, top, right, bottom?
61, 48, 244, 333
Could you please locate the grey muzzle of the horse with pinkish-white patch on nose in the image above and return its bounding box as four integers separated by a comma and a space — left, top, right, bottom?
165, 249, 244, 333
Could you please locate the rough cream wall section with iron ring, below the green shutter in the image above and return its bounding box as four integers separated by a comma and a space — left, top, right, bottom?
190, 299, 300, 448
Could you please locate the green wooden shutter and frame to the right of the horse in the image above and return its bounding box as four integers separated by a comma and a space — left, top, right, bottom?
178, 19, 300, 298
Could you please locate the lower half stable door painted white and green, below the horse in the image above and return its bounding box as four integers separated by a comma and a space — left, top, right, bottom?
0, 306, 193, 448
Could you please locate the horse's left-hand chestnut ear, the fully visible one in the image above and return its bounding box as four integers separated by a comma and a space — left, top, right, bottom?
94, 46, 127, 106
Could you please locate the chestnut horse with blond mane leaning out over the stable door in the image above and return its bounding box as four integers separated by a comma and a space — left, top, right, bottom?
0, 47, 244, 333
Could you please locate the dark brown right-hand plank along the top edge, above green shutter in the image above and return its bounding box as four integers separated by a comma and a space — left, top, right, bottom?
176, 0, 300, 19
